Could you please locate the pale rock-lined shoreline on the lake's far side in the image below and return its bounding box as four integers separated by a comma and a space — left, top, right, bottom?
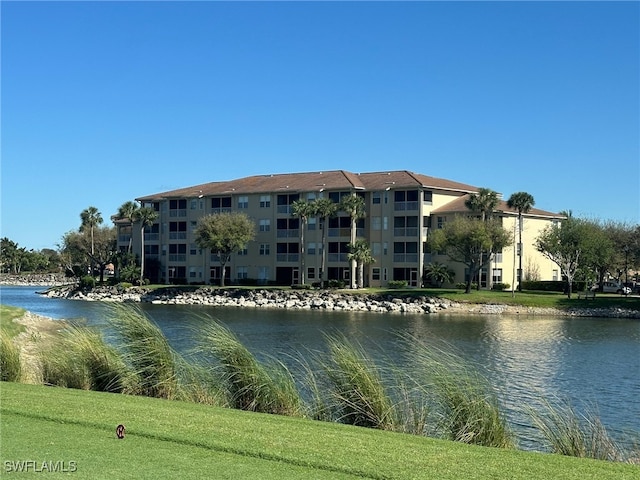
37, 286, 640, 319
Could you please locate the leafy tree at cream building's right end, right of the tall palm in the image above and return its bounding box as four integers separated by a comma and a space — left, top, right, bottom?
536, 216, 593, 298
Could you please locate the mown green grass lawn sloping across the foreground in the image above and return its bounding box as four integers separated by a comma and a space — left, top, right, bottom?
0, 383, 640, 480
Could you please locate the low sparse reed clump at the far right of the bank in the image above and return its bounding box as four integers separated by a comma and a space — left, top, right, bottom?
527, 399, 637, 462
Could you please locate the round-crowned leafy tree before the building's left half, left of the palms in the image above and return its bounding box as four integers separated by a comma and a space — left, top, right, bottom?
195, 212, 255, 287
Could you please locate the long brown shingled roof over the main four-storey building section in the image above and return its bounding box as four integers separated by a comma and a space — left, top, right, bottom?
137, 170, 477, 201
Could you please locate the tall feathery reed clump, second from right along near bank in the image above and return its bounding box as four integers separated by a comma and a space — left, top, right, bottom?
405, 337, 515, 448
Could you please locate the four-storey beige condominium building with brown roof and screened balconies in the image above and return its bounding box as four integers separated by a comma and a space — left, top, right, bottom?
116, 170, 562, 287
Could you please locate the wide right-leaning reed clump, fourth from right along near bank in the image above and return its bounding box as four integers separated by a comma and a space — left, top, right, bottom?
200, 320, 303, 416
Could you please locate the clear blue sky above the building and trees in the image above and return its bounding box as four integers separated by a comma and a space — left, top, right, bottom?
0, 1, 640, 249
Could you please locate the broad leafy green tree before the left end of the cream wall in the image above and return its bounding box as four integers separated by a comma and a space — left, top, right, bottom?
430, 215, 513, 293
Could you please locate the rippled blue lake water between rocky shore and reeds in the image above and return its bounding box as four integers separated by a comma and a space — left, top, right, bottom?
0, 287, 640, 446
